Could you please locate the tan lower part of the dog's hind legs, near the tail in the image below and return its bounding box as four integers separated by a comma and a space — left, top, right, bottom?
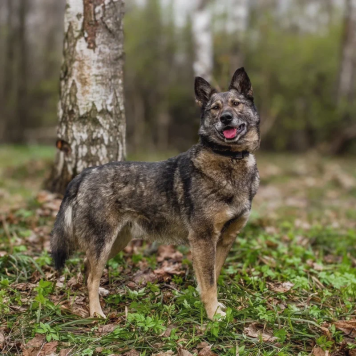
86, 224, 131, 318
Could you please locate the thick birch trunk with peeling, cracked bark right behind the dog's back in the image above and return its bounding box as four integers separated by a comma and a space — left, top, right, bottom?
48, 0, 126, 193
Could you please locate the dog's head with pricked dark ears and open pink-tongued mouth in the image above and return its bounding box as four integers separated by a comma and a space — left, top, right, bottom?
195, 68, 260, 152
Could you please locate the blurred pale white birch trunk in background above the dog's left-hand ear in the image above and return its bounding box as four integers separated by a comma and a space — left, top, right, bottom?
193, 0, 213, 81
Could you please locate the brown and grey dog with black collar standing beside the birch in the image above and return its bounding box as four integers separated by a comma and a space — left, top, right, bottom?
51, 68, 260, 319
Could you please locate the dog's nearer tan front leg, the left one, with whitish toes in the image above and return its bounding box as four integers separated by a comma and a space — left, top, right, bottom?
189, 233, 225, 319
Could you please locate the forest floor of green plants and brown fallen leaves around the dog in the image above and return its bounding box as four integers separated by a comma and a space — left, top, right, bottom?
0, 147, 356, 356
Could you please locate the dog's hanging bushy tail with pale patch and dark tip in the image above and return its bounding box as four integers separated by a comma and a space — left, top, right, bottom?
51, 180, 77, 271
